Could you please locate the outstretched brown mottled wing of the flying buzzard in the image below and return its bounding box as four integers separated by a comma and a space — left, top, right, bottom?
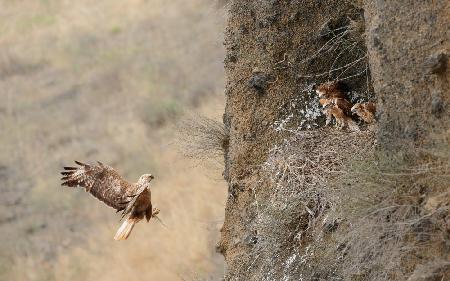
61, 161, 136, 211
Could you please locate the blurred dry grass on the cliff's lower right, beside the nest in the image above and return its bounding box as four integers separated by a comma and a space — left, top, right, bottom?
338, 145, 450, 280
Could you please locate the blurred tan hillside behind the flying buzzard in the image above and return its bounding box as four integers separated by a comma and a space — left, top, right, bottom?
0, 0, 226, 281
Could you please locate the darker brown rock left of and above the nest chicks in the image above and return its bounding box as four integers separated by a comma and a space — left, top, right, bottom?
218, 0, 373, 280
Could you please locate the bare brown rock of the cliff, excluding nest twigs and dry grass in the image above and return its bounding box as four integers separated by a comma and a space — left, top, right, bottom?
217, 0, 450, 280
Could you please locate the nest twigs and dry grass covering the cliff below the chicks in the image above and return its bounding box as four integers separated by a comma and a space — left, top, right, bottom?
259, 126, 450, 280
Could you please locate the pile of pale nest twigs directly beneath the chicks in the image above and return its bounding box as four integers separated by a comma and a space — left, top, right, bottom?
263, 128, 374, 223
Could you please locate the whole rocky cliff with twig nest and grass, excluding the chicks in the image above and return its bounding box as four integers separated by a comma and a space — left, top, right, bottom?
218, 0, 449, 280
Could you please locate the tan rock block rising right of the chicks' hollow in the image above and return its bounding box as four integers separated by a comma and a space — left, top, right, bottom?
365, 1, 450, 152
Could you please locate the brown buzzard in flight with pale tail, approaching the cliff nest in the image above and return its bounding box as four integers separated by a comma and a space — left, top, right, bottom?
61, 161, 159, 240
